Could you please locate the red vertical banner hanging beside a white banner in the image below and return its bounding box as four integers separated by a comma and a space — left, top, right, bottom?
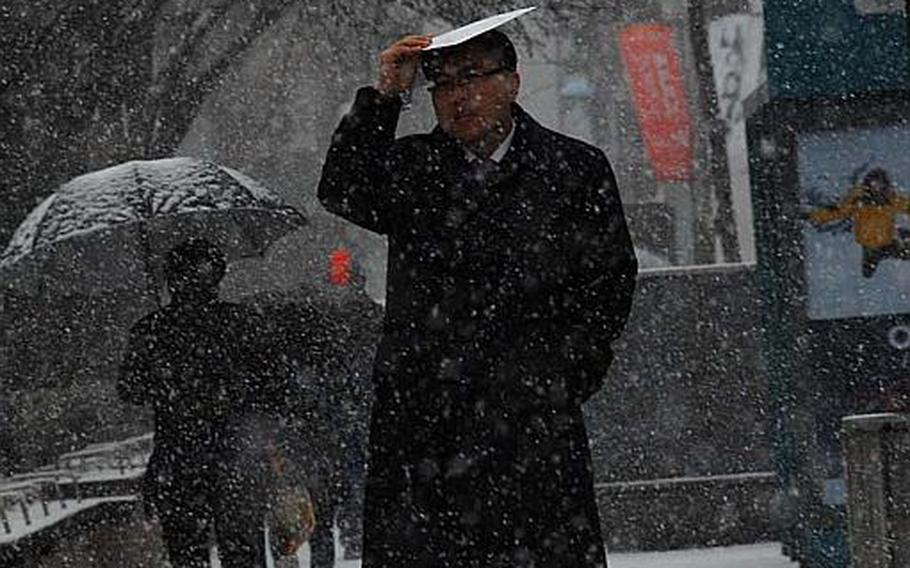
619, 24, 693, 181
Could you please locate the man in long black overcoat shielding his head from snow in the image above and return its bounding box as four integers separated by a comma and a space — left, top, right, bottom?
319, 30, 637, 568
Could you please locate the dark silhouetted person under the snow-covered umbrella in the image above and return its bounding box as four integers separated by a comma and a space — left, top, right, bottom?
118, 239, 292, 568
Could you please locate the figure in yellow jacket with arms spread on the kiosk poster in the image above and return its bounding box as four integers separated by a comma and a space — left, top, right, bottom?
808, 168, 910, 278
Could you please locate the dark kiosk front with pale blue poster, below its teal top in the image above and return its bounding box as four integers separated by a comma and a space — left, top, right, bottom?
747, 87, 910, 568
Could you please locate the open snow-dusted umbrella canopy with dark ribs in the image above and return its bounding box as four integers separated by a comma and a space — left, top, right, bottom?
0, 158, 306, 299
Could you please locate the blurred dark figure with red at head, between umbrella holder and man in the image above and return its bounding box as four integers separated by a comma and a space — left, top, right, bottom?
249, 248, 383, 568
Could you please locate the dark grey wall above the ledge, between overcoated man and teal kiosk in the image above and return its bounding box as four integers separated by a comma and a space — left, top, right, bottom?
586, 265, 771, 482
